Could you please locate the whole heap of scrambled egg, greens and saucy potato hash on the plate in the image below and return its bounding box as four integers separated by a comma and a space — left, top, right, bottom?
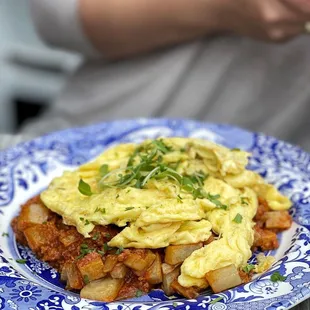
12, 138, 292, 301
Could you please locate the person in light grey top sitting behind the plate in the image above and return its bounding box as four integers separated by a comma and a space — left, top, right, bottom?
23, 0, 310, 150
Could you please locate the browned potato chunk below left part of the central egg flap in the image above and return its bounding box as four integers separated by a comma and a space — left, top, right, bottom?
124, 250, 156, 271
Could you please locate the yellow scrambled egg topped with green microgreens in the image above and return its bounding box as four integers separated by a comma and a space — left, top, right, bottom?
41, 138, 291, 288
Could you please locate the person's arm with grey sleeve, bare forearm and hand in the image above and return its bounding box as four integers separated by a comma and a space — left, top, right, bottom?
30, 0, 310, 59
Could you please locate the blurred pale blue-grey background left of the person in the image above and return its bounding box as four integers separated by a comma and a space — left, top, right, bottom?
0, 0, 82, 133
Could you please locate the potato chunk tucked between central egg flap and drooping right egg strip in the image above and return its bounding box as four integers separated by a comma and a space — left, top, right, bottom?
165, 243, 203, 265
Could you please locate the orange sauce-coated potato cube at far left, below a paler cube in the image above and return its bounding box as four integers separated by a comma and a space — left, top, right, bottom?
24, 224, 54, 251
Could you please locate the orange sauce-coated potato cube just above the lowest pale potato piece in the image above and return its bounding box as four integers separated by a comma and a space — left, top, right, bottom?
76, 252, 106, 281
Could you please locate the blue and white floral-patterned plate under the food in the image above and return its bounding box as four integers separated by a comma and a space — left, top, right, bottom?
0, 119, 310, 310
